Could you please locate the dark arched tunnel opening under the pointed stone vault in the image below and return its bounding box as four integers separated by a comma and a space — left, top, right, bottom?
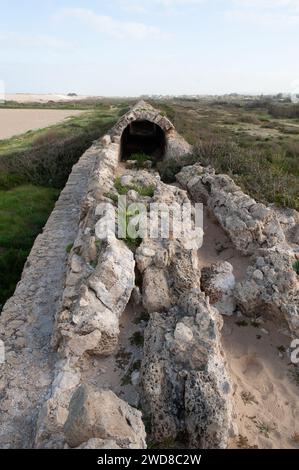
121, 120, 166, 164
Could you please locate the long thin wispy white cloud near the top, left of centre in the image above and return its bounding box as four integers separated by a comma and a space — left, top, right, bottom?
56, 8, 163, 39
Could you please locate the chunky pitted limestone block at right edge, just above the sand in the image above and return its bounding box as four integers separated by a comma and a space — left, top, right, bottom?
235, 248, 299, 336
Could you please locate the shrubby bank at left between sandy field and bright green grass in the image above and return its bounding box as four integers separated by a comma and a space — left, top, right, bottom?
0, 110, 117, 189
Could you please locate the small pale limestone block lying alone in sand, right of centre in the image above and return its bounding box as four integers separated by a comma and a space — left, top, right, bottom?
201, 261, 236, 315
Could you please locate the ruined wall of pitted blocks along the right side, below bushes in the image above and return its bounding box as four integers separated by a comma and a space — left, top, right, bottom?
177, 163, 299, 337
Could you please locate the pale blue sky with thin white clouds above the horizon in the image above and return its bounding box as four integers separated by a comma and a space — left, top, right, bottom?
0, 0, 299, 96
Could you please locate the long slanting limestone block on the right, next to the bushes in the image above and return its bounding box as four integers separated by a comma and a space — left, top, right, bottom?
177, 164, 286, 255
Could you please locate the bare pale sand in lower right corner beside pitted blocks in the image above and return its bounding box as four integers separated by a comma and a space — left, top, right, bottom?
222, 317, 299, 449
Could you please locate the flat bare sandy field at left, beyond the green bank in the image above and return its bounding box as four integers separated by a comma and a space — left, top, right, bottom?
0, 109, 86, 140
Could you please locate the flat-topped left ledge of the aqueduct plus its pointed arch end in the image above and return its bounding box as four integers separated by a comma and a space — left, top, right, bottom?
0, 101, 190, 448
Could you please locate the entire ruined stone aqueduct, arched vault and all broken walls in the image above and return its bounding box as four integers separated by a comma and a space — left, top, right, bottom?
0, 101, 299, 449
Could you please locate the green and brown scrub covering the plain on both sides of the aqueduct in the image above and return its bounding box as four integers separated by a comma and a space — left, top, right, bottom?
0, 96, 299, 312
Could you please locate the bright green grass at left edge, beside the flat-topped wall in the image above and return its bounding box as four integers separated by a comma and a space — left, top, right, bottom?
0, 185, 59, 310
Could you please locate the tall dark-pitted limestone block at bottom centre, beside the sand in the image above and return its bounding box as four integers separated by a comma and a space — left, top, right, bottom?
141, 289, 231, 448
